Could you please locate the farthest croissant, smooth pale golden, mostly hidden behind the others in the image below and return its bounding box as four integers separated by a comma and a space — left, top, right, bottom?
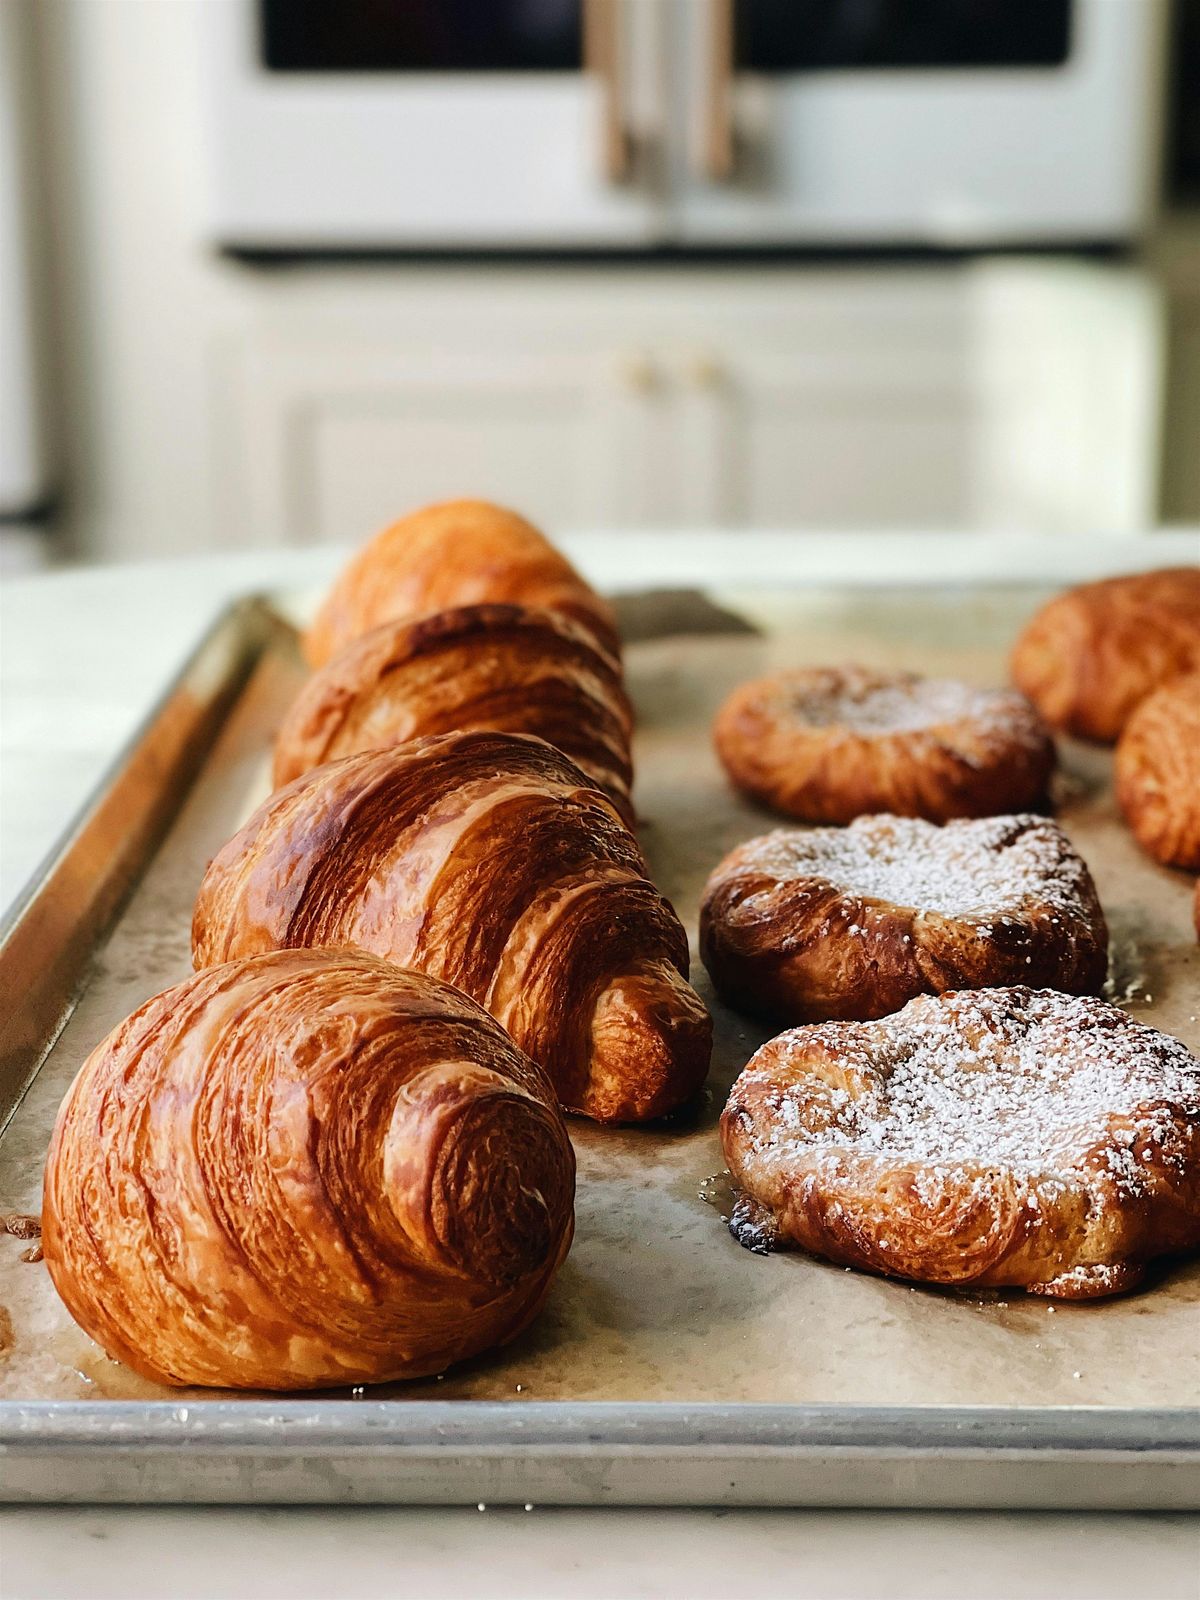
304, 501, 619, 667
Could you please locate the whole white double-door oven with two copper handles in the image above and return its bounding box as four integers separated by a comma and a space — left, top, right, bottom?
206, 0, 1165, 251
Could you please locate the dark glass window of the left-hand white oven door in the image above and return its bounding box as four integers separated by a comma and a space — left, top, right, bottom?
259, 0, 581, 72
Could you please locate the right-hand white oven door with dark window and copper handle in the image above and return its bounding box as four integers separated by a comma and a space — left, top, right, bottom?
674, 0, 1165, 248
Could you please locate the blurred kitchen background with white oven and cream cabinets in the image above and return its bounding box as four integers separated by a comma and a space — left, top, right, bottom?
0, 0, 1200, 571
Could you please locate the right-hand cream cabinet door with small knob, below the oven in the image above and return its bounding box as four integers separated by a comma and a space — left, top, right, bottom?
677, 272, 971, 528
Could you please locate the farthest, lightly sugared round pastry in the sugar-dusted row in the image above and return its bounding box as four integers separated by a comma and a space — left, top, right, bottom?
714, 667, 1054, 822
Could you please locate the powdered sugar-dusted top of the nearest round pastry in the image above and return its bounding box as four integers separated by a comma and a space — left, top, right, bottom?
734, 989, 1200, 1205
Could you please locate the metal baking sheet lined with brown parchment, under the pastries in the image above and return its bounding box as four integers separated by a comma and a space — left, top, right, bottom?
0, 589, 1200, 1509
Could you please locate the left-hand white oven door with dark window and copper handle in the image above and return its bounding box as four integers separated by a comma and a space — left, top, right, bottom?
205, 0, 666, 251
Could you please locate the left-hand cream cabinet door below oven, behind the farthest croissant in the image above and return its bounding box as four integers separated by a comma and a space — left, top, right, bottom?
227, 318, 664, 544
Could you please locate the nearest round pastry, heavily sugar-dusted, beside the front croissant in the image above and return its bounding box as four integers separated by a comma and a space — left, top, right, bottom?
722, 989, 1200, 1299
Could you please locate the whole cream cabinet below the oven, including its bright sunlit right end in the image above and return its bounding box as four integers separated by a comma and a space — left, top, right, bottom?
216, 262, 1162, 544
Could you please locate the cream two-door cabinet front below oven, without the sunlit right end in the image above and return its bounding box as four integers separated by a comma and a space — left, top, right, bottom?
224, 267, 998, 542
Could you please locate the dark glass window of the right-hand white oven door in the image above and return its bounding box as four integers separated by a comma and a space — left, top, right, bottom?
736, 0, 1072, 72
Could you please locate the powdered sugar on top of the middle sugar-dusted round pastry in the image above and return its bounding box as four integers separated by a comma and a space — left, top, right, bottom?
738, 814, 1094, 922
